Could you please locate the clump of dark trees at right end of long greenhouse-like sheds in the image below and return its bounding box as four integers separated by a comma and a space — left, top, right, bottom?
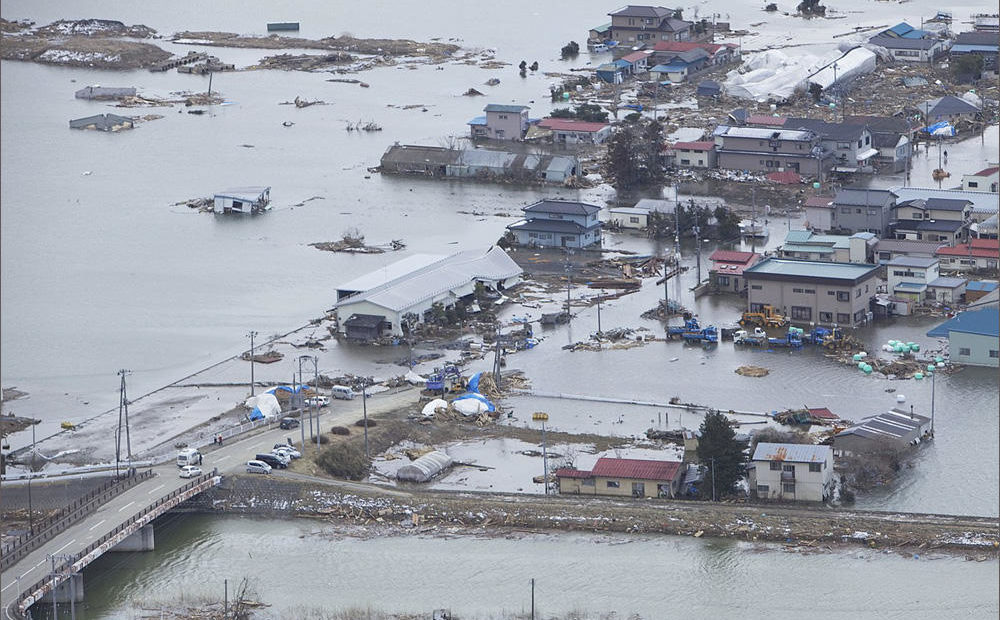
604, 118, 664, 190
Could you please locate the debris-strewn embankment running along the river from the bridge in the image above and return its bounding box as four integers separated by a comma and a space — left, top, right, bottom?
178, 474, 1000, 560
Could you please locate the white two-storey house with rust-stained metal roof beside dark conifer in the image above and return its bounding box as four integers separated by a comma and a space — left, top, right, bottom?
747, 442, 833, 502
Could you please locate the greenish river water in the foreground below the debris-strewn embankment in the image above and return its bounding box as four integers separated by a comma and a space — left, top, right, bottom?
56, 514, 1000, 620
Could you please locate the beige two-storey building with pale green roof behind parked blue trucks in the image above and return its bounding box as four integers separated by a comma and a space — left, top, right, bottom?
743, 258, 879, 327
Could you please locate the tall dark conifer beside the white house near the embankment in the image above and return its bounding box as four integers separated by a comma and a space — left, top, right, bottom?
698, 410, 747, 499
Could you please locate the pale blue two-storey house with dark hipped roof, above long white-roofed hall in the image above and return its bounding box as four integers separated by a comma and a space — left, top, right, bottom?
507, 198, 601, 248
